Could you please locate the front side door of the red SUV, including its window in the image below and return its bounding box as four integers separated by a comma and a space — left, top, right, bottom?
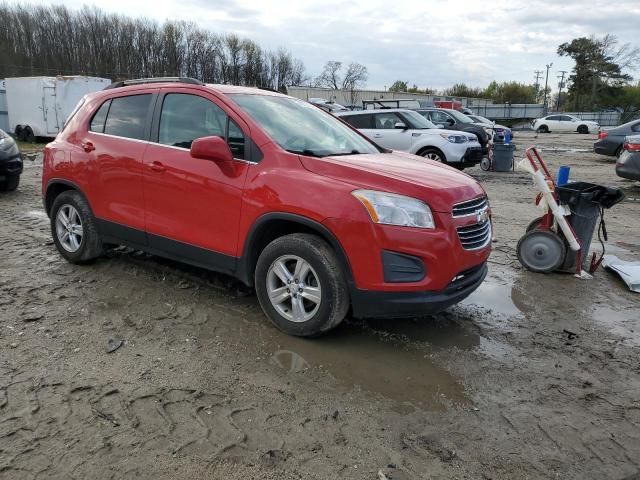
143, 90, 251, 271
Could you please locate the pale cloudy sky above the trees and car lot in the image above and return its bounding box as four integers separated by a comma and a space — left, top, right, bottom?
15, 0, 640, 89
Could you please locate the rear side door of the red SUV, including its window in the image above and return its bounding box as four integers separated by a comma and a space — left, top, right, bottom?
81, 90, 156, 245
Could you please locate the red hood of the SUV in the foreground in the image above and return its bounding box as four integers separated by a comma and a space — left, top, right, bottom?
300, 149, 485, 213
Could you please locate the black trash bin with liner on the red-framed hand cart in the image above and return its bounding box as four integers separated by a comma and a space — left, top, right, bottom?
556, 182, 624, 272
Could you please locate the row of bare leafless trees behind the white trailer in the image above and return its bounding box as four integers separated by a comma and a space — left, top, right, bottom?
0, 0, 305, 90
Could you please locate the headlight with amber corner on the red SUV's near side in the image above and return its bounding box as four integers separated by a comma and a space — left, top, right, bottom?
351, 190, 436, 229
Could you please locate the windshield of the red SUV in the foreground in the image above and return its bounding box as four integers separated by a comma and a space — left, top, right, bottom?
230, 94, 380, 157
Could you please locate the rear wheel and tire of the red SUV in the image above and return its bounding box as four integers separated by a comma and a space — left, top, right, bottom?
50, 190, 102, 265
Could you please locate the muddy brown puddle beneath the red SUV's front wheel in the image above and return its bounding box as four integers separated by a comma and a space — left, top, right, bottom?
203, 298, 480, 412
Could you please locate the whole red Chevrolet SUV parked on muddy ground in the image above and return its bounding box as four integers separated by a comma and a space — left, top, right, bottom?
42, 78, 492, 336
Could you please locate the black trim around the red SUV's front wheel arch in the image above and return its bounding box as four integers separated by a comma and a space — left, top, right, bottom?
236, 212, 355, 291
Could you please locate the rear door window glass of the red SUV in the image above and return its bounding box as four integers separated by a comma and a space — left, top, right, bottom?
104, 94, 151, 140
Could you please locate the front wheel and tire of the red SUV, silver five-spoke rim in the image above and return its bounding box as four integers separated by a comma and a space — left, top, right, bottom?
255, 233, 349, 337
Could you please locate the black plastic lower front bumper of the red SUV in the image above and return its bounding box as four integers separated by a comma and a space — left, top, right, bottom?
351, 262, 488, 318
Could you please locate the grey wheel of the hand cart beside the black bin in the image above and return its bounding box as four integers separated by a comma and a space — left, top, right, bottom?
517, 230, 567, 273
